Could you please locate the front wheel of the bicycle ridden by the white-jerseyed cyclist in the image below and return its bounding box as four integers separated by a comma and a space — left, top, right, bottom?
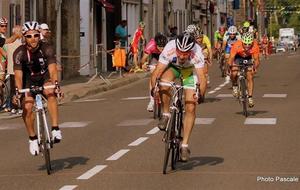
163, 111, 176, 174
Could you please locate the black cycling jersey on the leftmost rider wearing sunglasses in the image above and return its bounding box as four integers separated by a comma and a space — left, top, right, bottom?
13, 42, 56, 88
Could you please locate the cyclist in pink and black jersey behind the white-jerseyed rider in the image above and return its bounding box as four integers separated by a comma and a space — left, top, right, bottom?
141, 33, 168, 112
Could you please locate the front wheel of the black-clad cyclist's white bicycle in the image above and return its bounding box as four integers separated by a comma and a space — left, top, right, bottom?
39, 112, 51, 175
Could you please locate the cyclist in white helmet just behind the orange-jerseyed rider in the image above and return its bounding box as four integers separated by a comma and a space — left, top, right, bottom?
223, 26, 241, 81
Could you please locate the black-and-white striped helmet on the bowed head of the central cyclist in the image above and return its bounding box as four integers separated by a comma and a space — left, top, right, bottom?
175, 32, 196, 52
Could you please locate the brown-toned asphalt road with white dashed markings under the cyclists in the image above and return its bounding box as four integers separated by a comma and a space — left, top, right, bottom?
0, 50, 300, 190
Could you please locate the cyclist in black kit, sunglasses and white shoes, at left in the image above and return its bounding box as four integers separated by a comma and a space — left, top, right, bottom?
13, 21, 62, 155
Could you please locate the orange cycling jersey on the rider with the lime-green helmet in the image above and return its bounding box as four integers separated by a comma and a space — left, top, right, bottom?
230, 40, 259, 58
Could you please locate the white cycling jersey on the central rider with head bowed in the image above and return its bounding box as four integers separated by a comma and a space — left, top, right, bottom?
159, 40, 204, 69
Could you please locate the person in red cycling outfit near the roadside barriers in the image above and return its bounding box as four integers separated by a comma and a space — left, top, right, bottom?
130, 22, 145, 72
